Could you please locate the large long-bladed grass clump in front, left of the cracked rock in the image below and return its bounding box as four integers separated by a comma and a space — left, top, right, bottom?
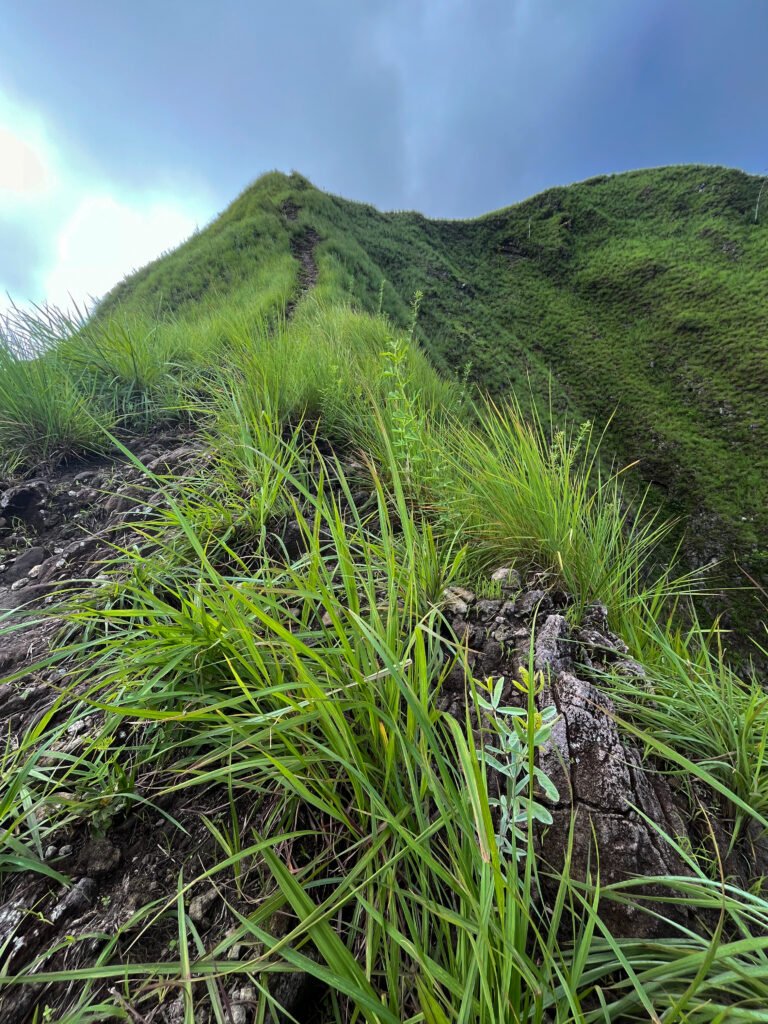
6, 438, 768, 1024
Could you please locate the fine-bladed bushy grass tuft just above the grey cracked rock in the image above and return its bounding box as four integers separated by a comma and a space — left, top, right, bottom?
436, 398, 694, 631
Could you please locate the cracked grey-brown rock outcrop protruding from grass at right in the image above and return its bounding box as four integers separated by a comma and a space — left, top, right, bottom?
439, 587, 688, 938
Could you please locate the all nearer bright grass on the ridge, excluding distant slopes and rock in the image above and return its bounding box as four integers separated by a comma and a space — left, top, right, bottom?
0, 302, 768, 1024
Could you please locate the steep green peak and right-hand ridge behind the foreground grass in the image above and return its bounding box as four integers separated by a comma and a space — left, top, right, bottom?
101, 167, 768, 627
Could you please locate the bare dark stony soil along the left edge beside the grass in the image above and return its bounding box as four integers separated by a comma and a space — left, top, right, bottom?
0, 432, 325, 1024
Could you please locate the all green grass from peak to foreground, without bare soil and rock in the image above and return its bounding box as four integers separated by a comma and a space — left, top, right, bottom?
0, 168, 768, 1024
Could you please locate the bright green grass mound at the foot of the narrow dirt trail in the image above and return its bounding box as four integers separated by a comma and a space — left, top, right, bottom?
204, 295, 457, 460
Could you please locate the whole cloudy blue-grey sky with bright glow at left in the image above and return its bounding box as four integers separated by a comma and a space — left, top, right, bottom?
0, 0, 768, 311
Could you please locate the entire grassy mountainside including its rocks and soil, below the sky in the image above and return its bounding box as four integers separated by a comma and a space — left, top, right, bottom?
0, 168, 768, 1024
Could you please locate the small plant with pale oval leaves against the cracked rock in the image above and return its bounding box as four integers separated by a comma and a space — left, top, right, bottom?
477, 668, 559, 860
